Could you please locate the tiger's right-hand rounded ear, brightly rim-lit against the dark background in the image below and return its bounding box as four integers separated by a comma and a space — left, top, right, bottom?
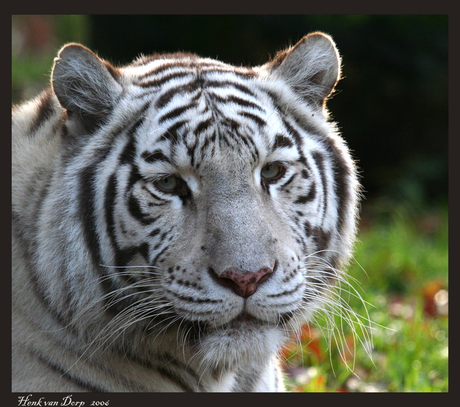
268, 32, 340, 107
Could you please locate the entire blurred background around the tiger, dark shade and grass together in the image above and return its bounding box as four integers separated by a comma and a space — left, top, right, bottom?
12, 15, 448, 391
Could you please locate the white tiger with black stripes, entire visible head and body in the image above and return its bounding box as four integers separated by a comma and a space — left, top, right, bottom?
12, 33, 359, 392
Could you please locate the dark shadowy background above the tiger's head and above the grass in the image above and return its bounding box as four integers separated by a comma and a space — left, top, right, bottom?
13, 15, 448, 207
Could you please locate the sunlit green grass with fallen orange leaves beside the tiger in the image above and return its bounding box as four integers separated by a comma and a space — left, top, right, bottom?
283, 204, 448, 392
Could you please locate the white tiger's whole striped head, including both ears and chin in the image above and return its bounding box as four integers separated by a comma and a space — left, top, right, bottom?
42, 33, 358, 365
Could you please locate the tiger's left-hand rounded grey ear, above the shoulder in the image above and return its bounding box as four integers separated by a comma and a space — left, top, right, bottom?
52, 44, 122, 132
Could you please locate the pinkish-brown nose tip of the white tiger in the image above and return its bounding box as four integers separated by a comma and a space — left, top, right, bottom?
211, 267, 273, 298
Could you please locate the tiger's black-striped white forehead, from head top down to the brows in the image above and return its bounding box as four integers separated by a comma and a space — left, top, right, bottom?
127, 57, 302, 169
